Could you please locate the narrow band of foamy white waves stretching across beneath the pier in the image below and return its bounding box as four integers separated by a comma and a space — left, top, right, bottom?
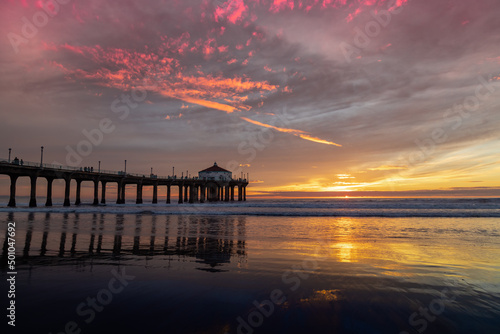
0, 198, 500, 217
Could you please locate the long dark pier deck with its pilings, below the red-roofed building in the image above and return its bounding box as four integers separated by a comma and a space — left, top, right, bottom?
0, 159, 248, 207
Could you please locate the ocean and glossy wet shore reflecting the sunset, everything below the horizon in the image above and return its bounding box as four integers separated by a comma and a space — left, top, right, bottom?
0, 198, 500, 334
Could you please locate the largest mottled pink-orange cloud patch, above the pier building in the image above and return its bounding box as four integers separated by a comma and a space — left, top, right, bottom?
45, 42, 279, 113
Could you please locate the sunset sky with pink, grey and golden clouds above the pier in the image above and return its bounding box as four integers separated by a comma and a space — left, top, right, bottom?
0, 0, 500, 197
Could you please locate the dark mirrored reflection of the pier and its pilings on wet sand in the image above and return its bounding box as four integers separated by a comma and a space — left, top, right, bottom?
2, 212, 246, 272
